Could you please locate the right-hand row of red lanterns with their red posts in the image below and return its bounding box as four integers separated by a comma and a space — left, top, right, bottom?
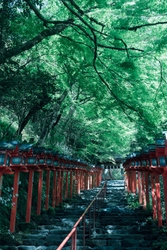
123, 133, 167, 226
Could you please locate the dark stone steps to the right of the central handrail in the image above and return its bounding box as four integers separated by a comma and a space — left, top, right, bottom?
88, 181, 153, 250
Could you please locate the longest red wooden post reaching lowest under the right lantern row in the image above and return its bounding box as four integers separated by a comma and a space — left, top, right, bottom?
155, 174, 162, 227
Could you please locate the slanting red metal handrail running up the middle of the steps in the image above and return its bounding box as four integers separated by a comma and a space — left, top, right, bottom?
56, 181, 107, 250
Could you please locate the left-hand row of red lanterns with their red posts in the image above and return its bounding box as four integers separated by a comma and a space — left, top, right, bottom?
0, 144, 102, 232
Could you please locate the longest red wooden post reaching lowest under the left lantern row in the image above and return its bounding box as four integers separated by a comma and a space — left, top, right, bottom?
10, 169, 20, 233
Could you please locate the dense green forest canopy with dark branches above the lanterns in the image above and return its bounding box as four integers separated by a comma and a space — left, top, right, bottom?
0, 0, 167, 162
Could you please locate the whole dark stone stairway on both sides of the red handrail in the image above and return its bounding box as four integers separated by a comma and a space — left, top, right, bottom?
0, 180, 164, 250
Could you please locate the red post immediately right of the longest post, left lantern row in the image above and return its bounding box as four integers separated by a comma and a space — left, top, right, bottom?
26, 168, 34, 223
